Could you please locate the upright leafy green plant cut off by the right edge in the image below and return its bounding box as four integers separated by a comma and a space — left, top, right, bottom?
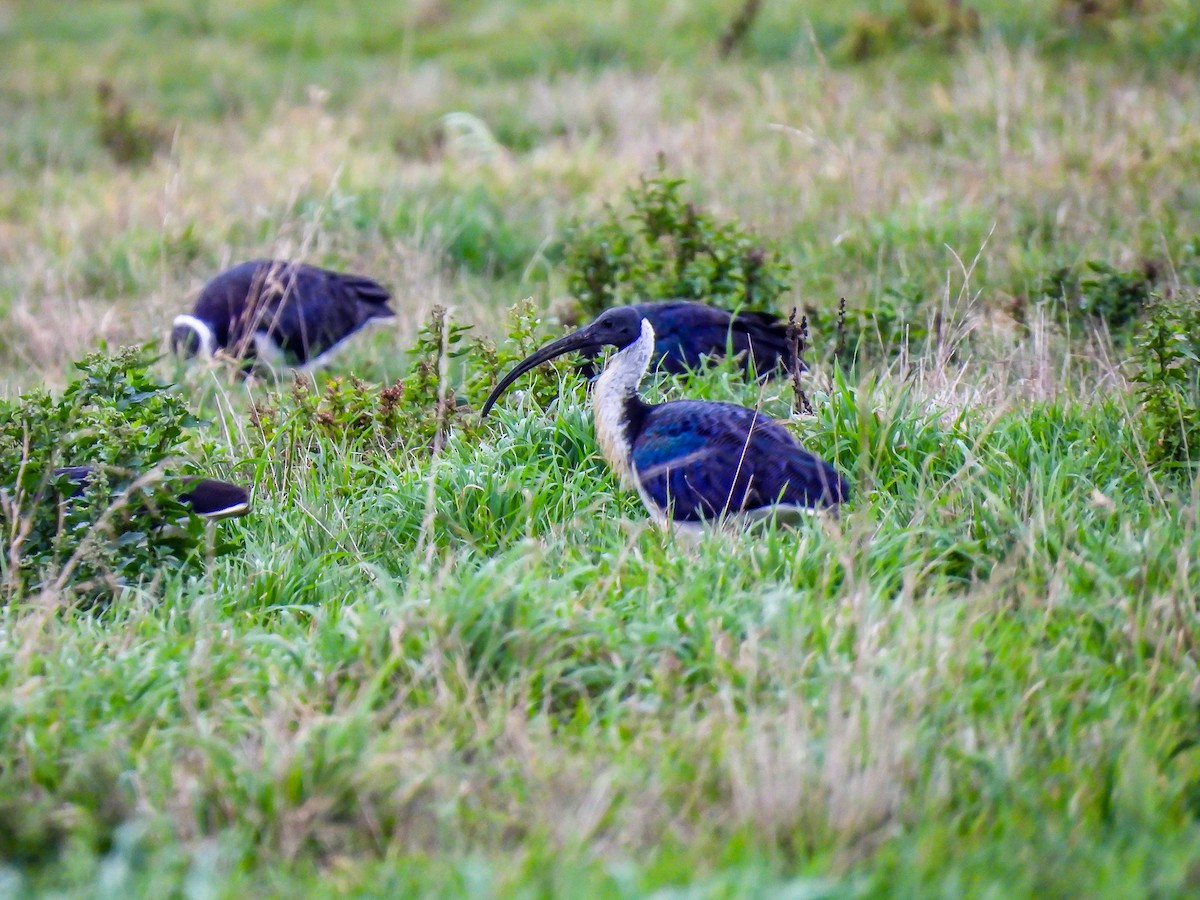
1133, 292, 1200, 468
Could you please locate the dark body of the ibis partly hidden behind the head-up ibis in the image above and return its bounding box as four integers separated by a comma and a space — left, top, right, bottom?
584, 300, 804, 380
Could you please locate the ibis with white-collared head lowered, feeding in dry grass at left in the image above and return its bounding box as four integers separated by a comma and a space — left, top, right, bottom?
170, 259, 396, 368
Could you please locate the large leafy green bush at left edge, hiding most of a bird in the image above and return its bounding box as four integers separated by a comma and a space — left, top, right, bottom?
0, 347, 225, 600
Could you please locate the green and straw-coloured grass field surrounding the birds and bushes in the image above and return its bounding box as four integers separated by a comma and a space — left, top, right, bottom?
0, 0, 1200, 898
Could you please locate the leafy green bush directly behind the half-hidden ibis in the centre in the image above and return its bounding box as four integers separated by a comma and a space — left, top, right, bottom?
564, 160, 791, 316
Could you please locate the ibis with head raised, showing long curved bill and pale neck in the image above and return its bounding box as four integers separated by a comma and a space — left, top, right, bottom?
481, 306, 850, 528
